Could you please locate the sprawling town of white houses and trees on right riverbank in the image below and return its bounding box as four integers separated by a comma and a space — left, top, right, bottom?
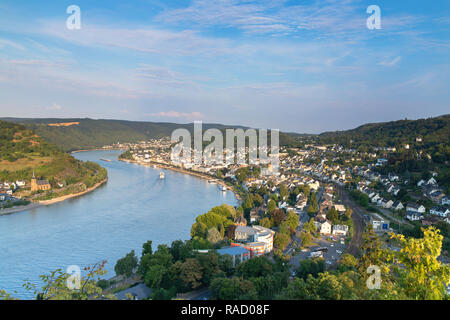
110, 137, 450, 286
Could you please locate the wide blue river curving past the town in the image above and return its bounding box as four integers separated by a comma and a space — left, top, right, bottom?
0, 151, 237, 298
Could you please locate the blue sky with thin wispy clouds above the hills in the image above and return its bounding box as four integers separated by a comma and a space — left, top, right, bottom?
0, 0, 450, 133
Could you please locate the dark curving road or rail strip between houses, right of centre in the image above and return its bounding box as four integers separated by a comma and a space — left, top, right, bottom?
337, 187, 367, 257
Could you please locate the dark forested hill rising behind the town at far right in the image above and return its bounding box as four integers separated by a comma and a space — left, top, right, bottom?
318, 115, 450, 148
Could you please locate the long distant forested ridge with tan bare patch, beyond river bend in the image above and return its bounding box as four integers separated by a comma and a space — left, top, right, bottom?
1, 118, 306, 151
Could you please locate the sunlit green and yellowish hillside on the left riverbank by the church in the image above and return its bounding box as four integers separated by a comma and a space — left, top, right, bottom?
0, 121, 107, 200
